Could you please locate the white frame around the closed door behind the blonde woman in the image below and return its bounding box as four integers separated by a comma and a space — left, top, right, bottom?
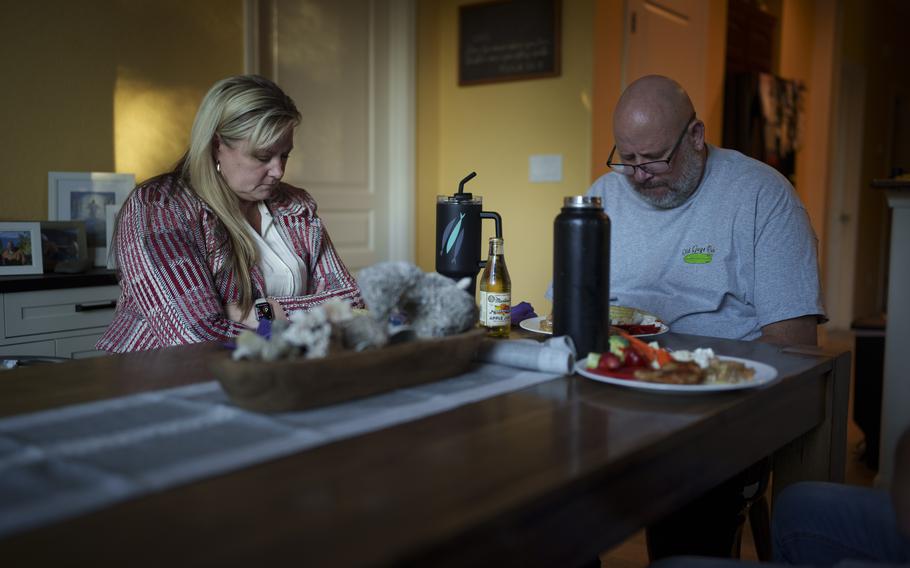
243, 0, 417, 262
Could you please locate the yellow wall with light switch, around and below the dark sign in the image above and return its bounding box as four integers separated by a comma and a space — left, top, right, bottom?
416, 0, 594, 314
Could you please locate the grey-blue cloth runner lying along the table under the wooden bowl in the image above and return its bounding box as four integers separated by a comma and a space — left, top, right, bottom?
0, 364, 561, 537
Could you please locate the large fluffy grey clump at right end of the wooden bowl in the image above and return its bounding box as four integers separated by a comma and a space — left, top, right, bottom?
357, 261, 477, 338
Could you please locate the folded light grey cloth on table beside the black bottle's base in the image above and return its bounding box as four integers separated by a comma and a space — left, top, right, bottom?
477, 335, 575, 375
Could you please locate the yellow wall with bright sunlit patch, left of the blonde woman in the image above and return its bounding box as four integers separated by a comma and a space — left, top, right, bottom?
0, 0, 243, 220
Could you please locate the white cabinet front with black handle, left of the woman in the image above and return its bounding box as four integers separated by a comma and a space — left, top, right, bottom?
0, 285, 120, 359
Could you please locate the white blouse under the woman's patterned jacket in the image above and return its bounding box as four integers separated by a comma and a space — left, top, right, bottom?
247, 201, 307, 296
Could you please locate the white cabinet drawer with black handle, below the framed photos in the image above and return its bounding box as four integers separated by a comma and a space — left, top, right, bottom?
3, 286, 120, 337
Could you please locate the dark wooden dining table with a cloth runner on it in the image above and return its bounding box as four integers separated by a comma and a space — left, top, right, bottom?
0, 333, 850, 567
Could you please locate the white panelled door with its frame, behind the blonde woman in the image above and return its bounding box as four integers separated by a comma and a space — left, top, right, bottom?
245, 0, 416, 272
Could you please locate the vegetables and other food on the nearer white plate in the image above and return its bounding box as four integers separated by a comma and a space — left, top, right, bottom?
585, 329, 755, 385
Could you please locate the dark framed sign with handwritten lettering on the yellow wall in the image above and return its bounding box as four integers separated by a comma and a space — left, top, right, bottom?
458, 0, 562, 86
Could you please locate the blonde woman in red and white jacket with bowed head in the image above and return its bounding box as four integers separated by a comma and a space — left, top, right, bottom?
98, 75, 362, 352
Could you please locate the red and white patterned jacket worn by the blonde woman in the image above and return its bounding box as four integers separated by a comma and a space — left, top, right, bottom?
97, 174, 363, 353
